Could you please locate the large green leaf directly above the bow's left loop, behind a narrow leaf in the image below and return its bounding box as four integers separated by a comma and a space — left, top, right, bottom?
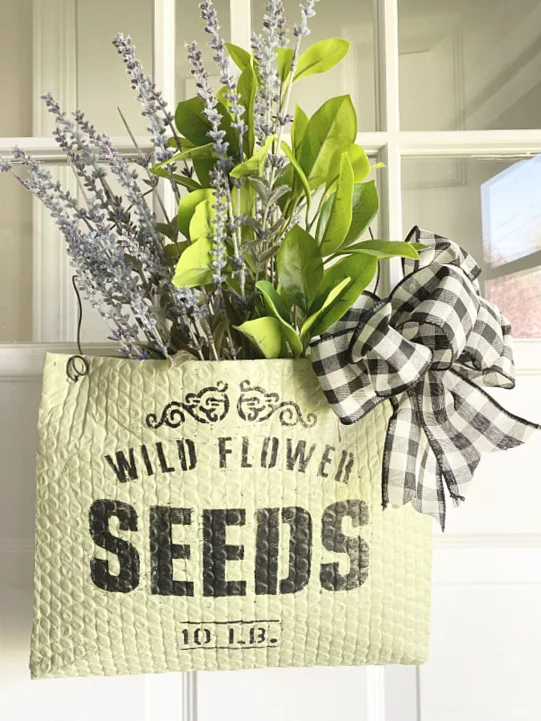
308, 255, 378, 335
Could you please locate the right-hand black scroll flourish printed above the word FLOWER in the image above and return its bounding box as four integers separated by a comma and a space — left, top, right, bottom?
237, 380, 317, 428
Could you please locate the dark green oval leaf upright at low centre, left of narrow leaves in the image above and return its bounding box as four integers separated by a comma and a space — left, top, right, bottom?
276, 225, 323, 310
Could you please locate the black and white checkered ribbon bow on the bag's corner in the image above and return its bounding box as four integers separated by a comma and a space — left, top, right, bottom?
311, 228, 539, 530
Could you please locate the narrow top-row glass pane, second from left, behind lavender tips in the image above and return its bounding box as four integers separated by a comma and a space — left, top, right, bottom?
175, 0, 231, 101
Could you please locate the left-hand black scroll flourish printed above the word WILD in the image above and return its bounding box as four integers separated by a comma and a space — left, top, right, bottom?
146, 381, 230, 428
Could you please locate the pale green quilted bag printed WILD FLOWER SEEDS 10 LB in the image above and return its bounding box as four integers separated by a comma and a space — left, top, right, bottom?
30, 355, 432, 678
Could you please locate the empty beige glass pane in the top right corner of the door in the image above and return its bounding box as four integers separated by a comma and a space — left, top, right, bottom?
398, 0, 541, 130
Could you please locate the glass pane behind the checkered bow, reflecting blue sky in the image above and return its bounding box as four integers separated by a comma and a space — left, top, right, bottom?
403, 156, 541, 338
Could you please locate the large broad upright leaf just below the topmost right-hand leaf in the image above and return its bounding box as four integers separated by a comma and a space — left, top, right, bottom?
299, 95, 357, 189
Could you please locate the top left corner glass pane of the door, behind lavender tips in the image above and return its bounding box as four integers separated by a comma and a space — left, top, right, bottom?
0, 0, 152, 137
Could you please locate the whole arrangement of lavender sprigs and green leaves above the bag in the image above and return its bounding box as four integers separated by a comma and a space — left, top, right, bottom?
0, 0, 423, 360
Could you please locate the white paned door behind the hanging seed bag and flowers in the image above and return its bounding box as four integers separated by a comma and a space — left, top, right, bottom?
0, 0, 541, 721
